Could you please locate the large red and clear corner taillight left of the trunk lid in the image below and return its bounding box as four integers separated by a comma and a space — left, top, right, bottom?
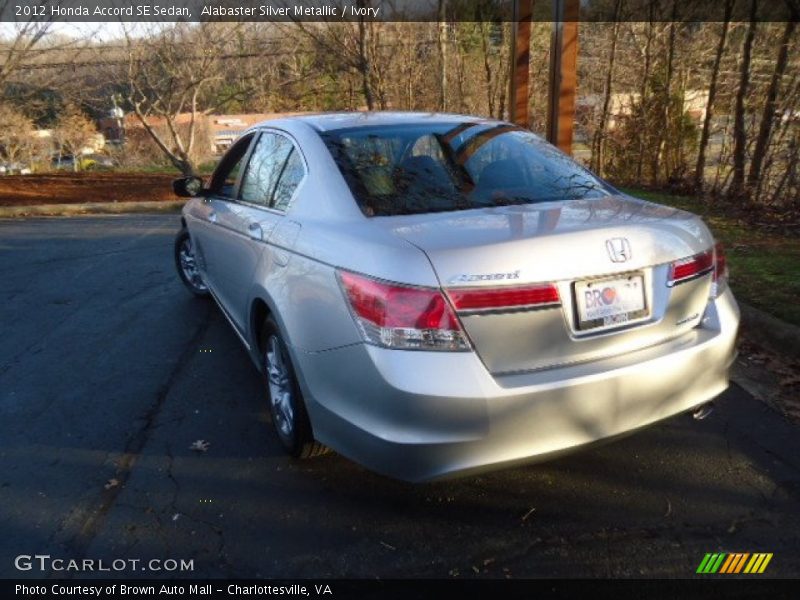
339, 271, 469, 350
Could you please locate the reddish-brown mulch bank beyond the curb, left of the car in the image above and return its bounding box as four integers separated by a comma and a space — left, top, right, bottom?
0, 172, 178, 206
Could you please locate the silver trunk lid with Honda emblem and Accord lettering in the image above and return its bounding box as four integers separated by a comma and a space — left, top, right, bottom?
375, 196, 713, 374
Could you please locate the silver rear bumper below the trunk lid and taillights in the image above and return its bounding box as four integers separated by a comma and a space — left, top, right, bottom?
293, 290, 739, 481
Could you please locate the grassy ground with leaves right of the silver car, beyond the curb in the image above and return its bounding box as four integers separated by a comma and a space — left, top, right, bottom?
624, 189, 800, 325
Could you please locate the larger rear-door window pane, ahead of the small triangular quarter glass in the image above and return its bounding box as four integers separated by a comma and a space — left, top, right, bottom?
239, 132, 293, 206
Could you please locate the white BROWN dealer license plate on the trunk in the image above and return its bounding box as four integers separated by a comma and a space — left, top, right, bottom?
575, 273, 647, 330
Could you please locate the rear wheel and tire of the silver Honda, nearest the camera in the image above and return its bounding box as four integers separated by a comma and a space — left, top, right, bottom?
258, 316, 328, 458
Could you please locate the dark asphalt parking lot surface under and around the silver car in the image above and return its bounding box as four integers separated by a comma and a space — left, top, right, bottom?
0, 215, 800, 578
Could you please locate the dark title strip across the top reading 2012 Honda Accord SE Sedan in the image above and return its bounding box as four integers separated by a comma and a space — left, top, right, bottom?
0, 0, 800, 23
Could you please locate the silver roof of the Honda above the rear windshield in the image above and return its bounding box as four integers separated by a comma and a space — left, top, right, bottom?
253, 111, 501, 132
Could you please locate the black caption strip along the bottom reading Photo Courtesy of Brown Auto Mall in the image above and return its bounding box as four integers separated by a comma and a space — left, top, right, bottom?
0, 576, 800, 600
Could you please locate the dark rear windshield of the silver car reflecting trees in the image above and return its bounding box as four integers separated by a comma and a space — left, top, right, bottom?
322, 123, 614, 216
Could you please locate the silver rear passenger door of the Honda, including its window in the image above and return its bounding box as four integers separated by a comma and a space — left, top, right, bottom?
208, 130, 305, 332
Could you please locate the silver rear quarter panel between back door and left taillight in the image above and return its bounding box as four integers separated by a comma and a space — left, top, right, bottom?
251, 121, 438, 352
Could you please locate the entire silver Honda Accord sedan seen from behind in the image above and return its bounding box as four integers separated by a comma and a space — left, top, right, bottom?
175, 113, 739, 481
